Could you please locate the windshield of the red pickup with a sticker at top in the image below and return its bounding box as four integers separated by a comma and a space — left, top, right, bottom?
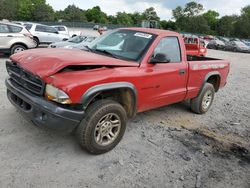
88, 29, 156, 61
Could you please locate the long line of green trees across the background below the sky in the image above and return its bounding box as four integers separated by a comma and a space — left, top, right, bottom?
0, 0, 250, 38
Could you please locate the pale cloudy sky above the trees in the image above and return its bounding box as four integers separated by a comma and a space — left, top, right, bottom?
47, 0, 250, 20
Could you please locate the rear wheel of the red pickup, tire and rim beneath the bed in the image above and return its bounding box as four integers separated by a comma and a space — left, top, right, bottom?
191, 83, 215, 114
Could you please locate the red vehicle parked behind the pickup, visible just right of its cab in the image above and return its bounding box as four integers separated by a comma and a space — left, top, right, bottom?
184, 37, 207, 56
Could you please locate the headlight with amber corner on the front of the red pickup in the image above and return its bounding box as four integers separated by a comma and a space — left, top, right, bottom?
45, 84, 72, 104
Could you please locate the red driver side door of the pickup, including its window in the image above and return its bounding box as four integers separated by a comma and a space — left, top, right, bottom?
141, 36, 188, 111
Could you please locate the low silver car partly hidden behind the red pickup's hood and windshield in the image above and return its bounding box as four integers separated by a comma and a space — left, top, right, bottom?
48, 35, 96, 49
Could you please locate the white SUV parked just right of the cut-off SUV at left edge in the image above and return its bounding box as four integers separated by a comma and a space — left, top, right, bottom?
23, 23, 69, 45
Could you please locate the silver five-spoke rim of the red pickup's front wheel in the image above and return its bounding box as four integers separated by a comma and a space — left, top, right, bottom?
95, 113, 121, 146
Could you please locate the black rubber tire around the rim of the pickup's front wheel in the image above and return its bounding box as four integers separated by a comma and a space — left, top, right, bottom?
76, 99, 127, 155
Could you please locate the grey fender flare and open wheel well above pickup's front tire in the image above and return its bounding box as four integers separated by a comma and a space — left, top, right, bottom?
80, 82, 137, 117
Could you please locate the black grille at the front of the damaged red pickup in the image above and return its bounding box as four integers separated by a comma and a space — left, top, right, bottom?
6, 61, 45, 95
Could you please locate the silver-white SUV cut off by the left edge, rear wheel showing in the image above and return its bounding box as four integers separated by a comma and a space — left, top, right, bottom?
0, 22, 36, 54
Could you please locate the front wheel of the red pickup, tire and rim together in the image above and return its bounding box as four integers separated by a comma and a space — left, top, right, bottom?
76, 100, 127, 154
